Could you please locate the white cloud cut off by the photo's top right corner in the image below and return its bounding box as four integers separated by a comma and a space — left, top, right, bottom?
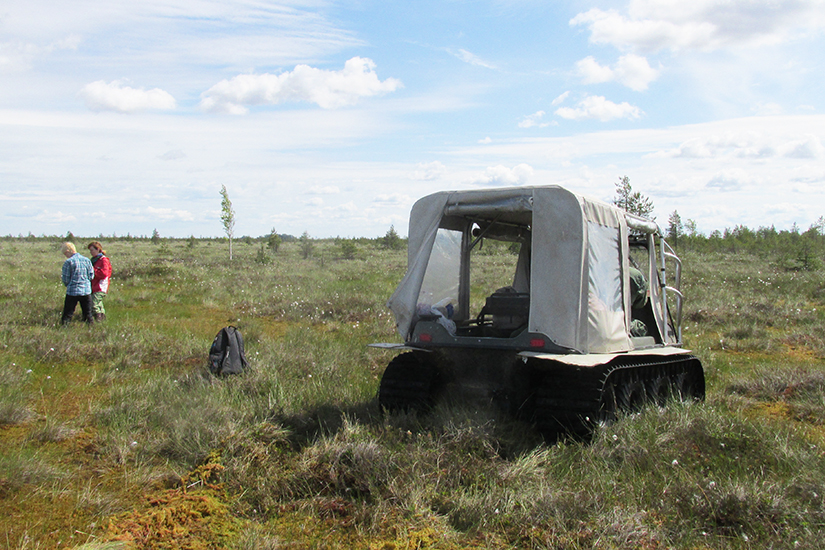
570, 0, 825, 52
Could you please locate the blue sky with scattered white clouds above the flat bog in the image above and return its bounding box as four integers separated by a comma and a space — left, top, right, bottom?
0, 0, 825, 238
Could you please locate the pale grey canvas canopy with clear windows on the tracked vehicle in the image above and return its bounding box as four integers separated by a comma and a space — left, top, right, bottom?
388, 186, 657, 353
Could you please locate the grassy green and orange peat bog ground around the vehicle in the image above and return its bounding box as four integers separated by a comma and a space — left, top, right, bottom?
0, 238, 825, 550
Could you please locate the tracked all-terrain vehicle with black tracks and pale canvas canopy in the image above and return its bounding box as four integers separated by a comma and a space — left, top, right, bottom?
374, 186, 705, 434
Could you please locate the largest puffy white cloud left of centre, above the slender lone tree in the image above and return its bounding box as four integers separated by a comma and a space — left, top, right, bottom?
200, 57, 402, 114
